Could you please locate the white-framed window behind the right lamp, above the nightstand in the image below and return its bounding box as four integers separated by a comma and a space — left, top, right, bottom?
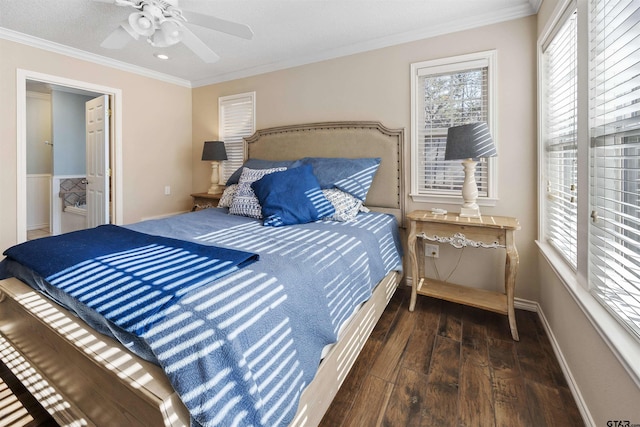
411, 51, 497, 205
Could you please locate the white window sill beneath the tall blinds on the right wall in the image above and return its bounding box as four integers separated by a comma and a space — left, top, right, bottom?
536, 241, 640, 387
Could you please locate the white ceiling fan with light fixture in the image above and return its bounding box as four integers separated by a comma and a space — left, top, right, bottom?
93, 0, 253, 63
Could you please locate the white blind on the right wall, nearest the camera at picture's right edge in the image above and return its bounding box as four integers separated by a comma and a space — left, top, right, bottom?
589, 0, 640, 337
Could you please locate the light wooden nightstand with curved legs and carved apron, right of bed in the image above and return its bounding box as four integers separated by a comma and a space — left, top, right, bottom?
407, 211, 520, 341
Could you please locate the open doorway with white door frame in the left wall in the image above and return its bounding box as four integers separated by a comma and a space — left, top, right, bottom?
17, 70, 122, 242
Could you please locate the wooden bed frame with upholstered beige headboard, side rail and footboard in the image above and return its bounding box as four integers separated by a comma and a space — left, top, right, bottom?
0, 122, 404, 427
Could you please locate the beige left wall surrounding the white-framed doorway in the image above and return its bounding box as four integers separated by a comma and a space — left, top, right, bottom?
0, 39, 192, 251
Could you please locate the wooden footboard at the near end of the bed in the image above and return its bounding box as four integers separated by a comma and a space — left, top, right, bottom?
0, 278, 189, 427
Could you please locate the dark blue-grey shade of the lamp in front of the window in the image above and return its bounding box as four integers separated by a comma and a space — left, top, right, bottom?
444, 122, 498, 160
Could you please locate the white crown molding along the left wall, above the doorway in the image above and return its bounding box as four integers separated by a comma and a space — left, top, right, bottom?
0, 27, 191, 87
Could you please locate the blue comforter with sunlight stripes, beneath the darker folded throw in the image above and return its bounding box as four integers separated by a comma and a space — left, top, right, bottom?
6, 209, 402, 426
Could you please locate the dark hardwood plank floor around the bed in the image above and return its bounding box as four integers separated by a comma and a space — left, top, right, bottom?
0, 287, 584, 427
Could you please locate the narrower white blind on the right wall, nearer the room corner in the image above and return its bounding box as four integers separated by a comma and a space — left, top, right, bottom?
543, 7, 578, 269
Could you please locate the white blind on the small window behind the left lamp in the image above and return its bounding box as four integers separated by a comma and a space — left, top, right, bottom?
218, 92, 256, 182
